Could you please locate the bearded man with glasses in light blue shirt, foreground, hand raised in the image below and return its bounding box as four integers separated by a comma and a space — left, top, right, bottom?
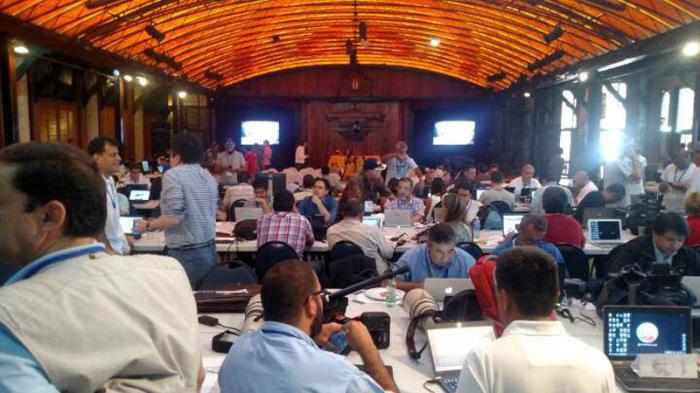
219, 260, 398, 393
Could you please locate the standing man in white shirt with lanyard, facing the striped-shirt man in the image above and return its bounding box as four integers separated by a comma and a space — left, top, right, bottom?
88, 136, 129, 255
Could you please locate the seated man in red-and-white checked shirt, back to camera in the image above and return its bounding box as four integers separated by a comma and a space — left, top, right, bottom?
257, 190, 314, 258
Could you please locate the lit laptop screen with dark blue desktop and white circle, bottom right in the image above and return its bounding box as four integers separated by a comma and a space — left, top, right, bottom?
603, 306, 691, 360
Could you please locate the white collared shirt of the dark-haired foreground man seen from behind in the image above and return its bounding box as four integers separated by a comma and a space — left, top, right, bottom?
457, 321, 617, 393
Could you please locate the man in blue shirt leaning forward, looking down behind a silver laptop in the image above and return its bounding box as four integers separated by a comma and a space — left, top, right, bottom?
392, 223, 475, 291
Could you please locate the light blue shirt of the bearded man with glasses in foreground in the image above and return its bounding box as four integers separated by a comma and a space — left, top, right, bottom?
219, 321, 384, 393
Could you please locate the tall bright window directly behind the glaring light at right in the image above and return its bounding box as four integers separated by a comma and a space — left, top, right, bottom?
599, 82, 627, 162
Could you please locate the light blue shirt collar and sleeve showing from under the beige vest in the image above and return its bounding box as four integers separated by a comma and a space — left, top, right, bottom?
0, 243, 104, 393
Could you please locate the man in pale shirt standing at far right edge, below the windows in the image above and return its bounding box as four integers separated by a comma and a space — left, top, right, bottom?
659, 151, 697, 214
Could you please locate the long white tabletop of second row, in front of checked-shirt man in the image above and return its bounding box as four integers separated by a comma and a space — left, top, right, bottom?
132, 222, 635, 256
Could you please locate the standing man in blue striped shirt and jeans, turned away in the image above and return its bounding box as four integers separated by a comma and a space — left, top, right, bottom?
137, 134, 219, 289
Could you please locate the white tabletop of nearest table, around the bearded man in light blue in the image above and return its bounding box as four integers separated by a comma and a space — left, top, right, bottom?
199, 293, 622, 393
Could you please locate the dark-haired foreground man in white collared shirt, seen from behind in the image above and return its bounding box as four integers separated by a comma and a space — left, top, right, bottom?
457, 247, 617, 393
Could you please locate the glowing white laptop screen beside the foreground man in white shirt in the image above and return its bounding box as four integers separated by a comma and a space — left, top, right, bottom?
428, 324, 496, 373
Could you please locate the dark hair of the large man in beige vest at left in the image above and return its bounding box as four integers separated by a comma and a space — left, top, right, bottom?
0, 142, 107, 237
